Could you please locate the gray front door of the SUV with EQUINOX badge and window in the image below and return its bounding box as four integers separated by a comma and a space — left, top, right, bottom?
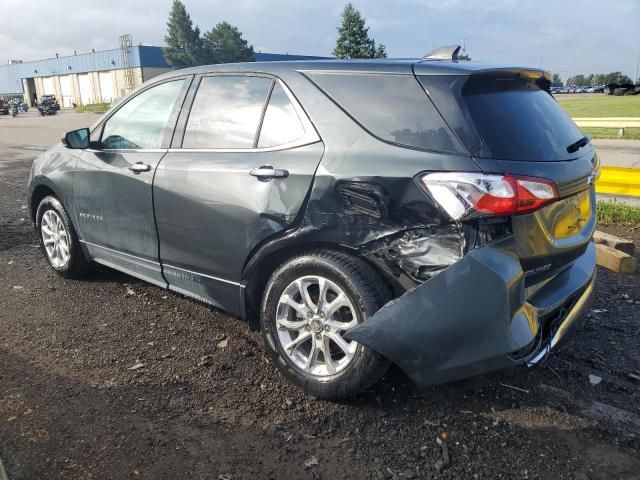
73, 77, 191, 286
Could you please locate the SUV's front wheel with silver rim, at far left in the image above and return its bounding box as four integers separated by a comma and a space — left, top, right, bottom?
36, 196, 89, 278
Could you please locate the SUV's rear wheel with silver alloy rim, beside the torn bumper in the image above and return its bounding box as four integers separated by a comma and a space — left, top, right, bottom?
261, 250, 391, 400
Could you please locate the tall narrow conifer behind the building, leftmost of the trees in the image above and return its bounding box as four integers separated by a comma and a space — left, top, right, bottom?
162, 0, 201, 68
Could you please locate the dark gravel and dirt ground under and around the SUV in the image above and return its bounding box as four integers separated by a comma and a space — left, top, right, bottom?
0, 141, 640, 480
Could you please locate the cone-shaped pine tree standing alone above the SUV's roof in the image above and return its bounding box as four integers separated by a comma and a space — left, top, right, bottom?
333, 2, 387, 58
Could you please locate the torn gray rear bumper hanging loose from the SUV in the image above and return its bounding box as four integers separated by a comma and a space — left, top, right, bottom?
346, 243, 596, 387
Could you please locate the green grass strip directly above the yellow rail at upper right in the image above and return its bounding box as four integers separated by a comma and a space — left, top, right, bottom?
556, 95, 640, 118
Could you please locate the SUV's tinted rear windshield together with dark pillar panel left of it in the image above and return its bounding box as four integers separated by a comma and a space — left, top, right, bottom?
420, 74, 583, 161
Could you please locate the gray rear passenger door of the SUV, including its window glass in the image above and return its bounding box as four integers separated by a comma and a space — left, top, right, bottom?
153, 75, 324, 314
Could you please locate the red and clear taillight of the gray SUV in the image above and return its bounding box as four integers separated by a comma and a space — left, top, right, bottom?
420, 172, 558, 220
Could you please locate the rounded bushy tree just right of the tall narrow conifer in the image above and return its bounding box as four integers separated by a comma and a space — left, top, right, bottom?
202, 22, 253, 64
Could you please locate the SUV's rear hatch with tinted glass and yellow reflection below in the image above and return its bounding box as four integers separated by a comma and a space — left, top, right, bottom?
414, 63, 599, 285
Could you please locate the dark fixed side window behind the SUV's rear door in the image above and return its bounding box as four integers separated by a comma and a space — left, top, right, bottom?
309, 73, 463, 153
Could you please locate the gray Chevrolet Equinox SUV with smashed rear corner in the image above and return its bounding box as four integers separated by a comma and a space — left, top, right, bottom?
28, 50, 598, 399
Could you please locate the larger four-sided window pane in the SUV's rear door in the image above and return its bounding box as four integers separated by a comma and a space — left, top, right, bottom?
182, 75, 273, 148
